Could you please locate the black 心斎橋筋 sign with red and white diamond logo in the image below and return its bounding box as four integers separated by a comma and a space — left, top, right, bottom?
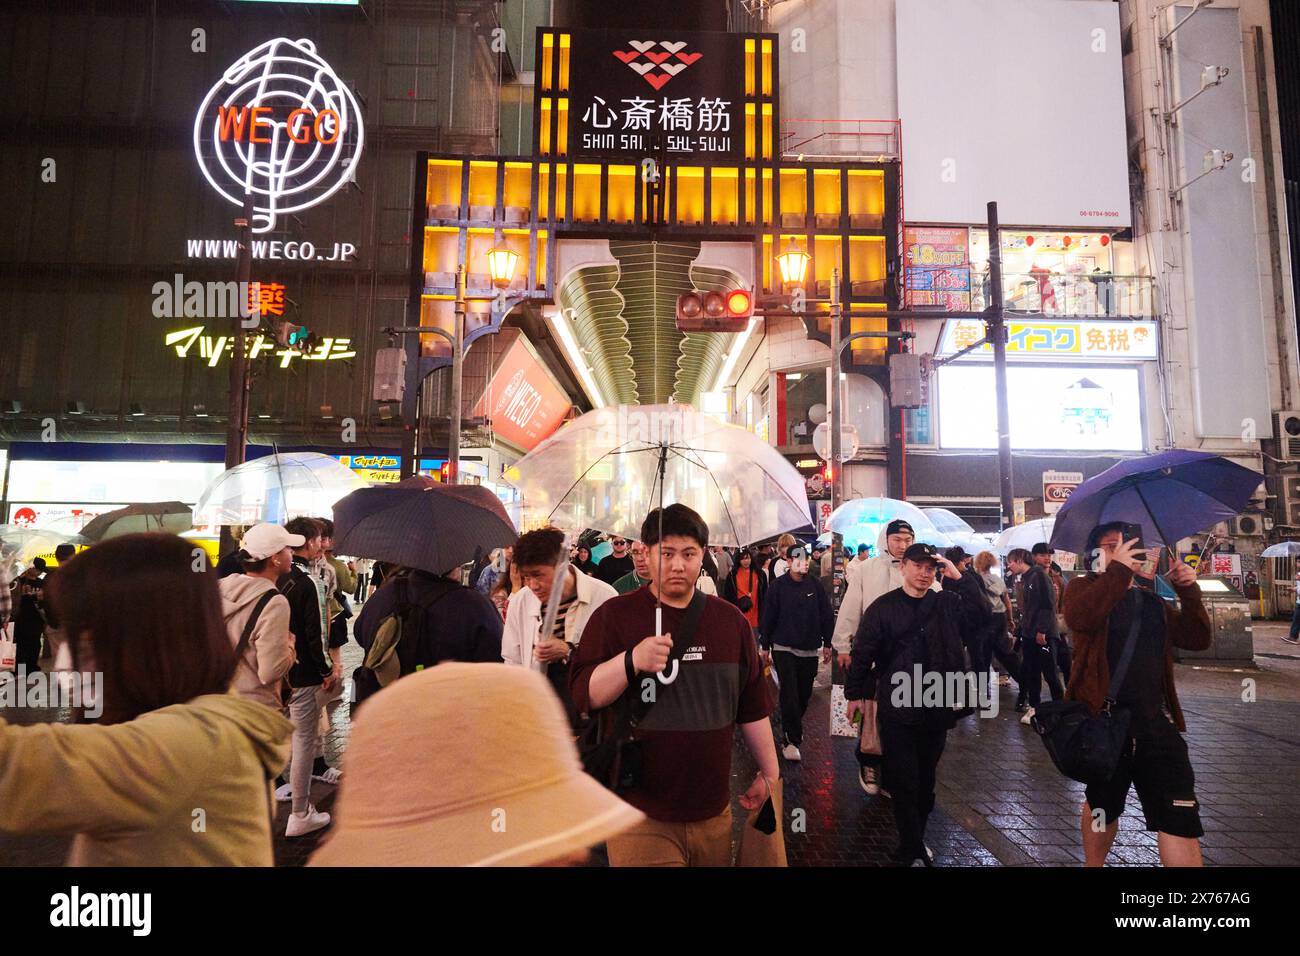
568, 30, 745, 159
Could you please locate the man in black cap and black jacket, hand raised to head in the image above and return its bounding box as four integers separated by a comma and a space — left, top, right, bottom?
844, 544, 987, 866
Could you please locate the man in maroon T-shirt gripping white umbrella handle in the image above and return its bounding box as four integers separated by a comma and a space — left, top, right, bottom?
569, 505, 780, 866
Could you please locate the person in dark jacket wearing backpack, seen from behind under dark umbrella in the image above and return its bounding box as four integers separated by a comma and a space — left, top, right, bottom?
352, 564, 502, 708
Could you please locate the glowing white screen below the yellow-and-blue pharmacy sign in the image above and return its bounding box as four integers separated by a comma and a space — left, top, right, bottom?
937, 364, 1144, 451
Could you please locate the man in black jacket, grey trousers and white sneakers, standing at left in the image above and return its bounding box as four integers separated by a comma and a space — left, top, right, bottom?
276, 518, 342, 836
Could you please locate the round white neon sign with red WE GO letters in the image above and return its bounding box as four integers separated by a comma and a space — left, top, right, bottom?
194, 38, 365, 233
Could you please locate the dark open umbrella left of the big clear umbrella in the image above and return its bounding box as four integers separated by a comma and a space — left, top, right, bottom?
334, 479, 519, 575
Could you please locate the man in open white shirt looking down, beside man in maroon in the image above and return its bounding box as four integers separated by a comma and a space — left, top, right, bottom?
501, 528, 618, 728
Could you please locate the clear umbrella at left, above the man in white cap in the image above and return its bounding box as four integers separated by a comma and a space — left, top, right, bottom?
194, 451, 367, 527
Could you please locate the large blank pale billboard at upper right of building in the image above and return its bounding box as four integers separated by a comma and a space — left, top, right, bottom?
896, 0, 1131, 229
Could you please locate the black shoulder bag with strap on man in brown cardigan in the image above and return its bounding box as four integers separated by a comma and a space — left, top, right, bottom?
1031, 595, 1141, 783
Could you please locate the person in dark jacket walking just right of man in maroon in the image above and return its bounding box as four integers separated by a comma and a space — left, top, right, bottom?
759, 546, 835, 761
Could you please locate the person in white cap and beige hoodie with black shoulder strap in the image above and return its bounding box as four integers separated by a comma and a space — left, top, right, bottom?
218, 524, 297, 711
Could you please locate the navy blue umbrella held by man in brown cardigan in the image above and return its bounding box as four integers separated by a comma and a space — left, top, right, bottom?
1050, 451, 1264, 554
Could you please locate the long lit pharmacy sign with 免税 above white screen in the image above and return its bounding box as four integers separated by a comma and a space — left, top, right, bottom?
937, 319, 1158, 362
